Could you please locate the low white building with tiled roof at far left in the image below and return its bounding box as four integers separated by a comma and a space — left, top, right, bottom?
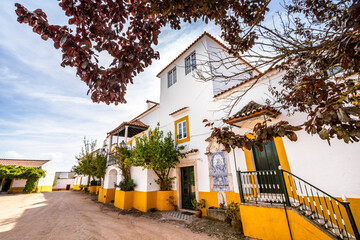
0, 159, 55, 193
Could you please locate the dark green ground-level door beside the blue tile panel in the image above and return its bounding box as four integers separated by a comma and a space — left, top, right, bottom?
181, 167, 195, 209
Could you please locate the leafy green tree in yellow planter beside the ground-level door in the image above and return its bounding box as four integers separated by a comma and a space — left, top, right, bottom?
132, 126, 185, 191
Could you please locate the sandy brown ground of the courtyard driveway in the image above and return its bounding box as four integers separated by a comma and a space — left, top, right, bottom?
0, 191, 213, 240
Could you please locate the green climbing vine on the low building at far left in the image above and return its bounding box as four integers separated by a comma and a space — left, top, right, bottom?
0, 165, 45, 193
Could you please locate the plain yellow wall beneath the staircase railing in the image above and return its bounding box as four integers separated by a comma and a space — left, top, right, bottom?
240, 204, 331, 240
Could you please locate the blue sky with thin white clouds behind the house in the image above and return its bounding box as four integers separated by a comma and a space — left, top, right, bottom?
0, 0, 220, 171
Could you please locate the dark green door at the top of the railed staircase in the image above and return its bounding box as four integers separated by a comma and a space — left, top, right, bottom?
252, 140, 280, 193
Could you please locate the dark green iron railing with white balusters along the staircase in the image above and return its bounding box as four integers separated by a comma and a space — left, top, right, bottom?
238, 169, 360, 240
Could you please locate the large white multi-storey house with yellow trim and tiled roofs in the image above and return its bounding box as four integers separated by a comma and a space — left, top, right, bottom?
99, 33, 360, 239
